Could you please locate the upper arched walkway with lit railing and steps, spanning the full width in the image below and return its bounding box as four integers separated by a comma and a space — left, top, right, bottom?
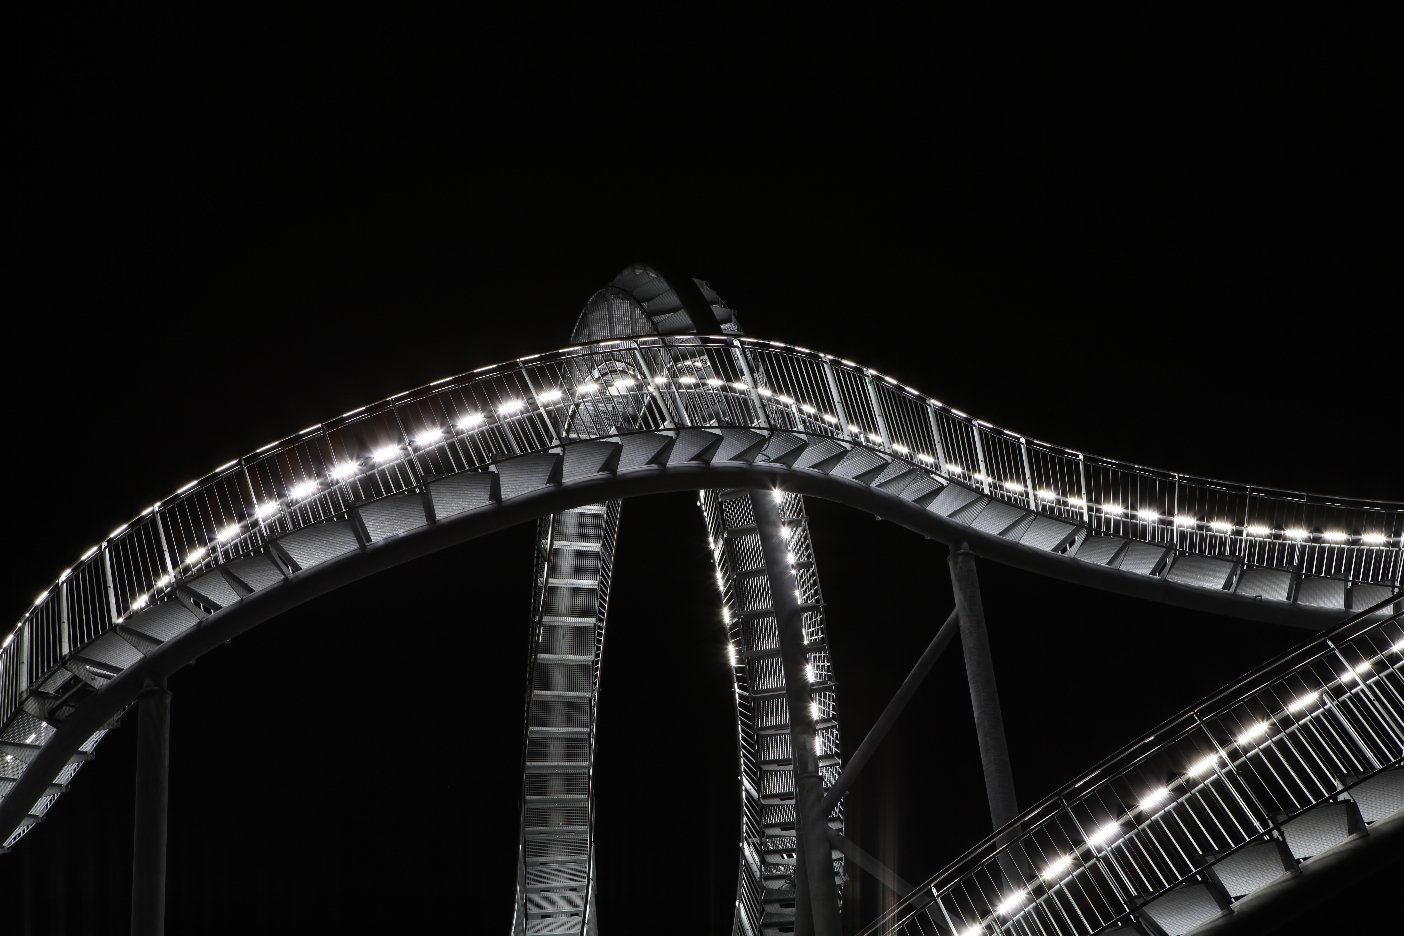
0, 337, 1401, 931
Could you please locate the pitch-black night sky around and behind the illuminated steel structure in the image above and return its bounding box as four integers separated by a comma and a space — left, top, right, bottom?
0, 14, 1404, 935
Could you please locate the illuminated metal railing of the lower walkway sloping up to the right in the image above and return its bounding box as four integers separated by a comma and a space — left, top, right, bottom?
862, 602, 1404, 936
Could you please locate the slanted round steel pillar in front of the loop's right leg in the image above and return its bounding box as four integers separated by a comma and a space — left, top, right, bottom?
751, 491, 841, 936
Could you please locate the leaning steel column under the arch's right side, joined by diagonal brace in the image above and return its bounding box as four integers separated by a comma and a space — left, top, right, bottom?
949, 543, 1019, 829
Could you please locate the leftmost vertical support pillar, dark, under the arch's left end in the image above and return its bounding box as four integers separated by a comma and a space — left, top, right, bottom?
132, 676, 171, 936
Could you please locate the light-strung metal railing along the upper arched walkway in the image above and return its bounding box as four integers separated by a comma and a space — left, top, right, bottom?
0, 337, 1404, 813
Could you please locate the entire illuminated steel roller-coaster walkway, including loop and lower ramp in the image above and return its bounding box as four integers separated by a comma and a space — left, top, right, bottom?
0, 268, 1404, 936
